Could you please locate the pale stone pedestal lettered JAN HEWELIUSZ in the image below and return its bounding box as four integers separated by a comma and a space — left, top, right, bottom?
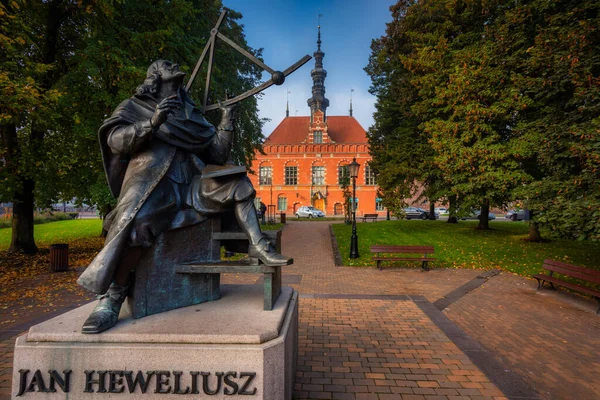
12, 285, 298, 400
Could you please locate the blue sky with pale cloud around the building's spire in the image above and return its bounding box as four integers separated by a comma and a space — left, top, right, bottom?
223, 0, 395, 136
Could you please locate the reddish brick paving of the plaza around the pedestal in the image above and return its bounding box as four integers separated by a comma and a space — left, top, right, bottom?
0, 222, 600, 400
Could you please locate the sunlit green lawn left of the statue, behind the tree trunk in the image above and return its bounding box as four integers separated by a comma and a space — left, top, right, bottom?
0, 219, 102, 250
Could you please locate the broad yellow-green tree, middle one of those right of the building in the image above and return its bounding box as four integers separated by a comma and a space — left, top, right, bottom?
403, 2, 531, 229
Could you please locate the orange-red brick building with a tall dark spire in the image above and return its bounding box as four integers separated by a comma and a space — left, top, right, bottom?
250, 27, 385, 216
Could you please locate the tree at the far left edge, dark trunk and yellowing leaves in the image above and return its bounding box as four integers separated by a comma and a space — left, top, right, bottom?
0, 0, 95, 253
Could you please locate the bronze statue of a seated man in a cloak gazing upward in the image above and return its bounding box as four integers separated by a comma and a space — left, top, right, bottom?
78, 60, 292, 333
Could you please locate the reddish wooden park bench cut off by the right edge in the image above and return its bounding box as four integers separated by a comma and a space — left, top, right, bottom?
532, 259, 600, 314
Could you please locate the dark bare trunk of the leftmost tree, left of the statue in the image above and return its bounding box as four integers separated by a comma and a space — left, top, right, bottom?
8, 179, 38, 254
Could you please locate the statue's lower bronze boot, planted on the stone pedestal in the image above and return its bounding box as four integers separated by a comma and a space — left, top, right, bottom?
81, 283, 128, 334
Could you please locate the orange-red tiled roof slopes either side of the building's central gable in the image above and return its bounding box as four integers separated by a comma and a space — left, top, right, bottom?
264, 116, 367, 145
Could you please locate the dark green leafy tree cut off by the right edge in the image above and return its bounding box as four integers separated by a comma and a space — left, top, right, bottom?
507, 0, 600, 240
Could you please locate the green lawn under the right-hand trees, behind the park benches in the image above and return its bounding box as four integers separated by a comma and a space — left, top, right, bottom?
333, 220, 600, 275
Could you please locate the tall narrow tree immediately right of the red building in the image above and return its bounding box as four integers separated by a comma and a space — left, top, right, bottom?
365, 1, 446, 218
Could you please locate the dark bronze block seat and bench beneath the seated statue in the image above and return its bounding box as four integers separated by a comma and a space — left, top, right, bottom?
127, 216, 283, 318
